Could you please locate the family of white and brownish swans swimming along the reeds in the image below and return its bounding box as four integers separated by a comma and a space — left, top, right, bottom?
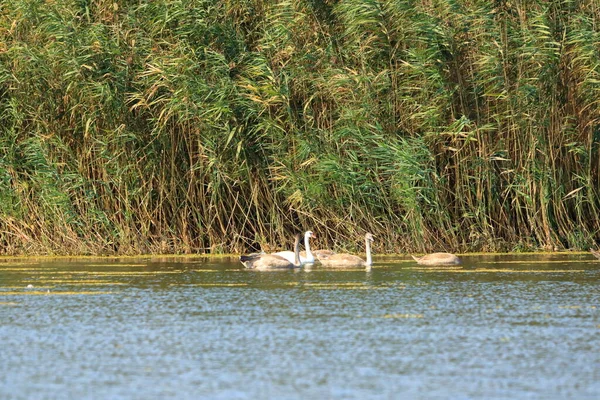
240, 231, 461, 270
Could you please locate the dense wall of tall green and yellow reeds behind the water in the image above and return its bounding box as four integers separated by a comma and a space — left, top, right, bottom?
0, 0, 600, 254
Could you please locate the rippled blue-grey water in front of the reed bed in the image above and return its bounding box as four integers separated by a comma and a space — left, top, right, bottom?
0, 254, 600, 400
